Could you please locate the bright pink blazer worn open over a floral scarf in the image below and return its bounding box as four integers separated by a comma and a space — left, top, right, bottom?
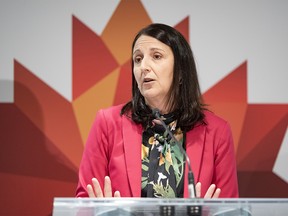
76, 105, 238, 198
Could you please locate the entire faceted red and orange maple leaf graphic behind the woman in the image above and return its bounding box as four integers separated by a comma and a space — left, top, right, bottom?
0, 1, 288, 214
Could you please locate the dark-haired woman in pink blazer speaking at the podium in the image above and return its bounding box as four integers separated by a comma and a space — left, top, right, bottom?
77, 24, 238, 198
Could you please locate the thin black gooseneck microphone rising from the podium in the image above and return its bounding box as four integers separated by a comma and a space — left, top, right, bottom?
152, 108, 196, 198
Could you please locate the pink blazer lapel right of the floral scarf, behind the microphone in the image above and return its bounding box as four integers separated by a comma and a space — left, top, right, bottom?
184, 125, 206, 197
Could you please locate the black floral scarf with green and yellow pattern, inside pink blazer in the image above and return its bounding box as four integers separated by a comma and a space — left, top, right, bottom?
141, 114, 185, 198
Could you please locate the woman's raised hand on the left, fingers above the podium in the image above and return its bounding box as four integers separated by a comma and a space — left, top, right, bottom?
87, 176, 121, 198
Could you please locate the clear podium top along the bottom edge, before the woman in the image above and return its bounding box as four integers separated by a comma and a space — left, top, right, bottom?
53, 198, 288, 216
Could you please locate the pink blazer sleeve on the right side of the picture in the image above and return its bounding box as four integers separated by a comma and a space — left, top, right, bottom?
213, 123, 239, 198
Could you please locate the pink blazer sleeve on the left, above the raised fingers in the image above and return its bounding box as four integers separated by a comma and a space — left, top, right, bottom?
76, 110, 109, 197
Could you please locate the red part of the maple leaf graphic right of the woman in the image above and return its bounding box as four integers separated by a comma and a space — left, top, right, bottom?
204, 62, 288, 197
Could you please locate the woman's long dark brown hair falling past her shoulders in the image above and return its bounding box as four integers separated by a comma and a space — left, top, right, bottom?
121, 23, 206, 131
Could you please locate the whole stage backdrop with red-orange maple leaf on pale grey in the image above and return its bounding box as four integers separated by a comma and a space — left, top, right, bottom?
0, 0, 288, 215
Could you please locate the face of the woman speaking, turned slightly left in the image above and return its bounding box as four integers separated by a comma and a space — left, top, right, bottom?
133, 35, 174, 113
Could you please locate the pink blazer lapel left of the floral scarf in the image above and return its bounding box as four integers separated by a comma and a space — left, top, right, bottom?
122, 117, 142, 197
